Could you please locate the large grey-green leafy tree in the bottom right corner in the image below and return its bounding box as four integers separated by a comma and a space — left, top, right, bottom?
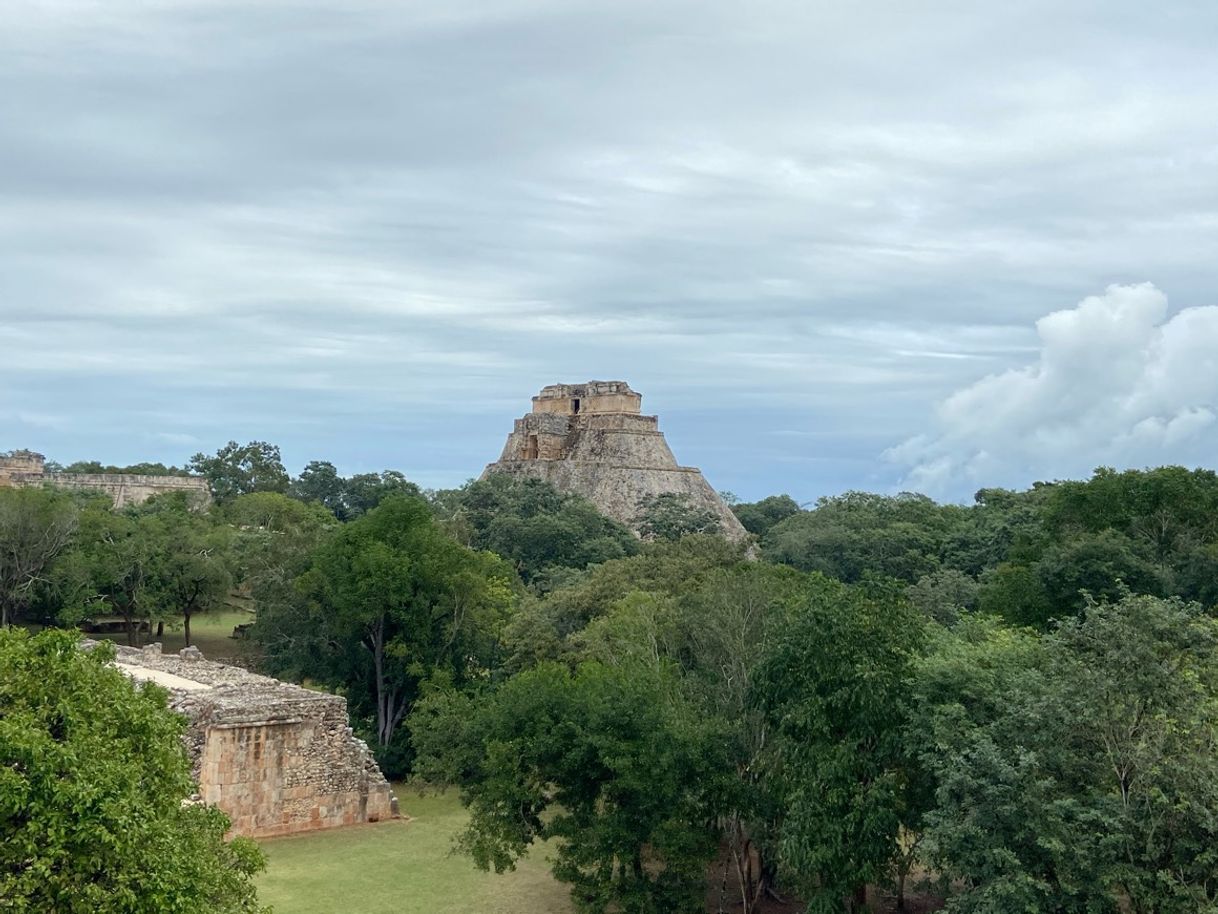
910, 596, 1218, 914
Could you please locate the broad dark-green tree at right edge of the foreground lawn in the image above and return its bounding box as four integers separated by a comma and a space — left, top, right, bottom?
412, 663, 727, 914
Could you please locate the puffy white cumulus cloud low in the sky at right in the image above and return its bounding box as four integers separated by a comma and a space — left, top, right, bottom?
885, 283, 1218, 497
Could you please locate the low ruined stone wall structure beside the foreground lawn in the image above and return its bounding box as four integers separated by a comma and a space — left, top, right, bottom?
105, 641, 397, 837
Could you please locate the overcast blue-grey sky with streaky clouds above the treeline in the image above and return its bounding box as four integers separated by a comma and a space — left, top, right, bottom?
0, 0, 1218, 502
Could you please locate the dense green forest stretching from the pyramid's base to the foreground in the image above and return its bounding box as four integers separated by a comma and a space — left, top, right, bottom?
0, 441, 1218, 914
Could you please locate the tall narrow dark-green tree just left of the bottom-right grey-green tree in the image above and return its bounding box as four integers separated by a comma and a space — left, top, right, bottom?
754, 576, 922, 912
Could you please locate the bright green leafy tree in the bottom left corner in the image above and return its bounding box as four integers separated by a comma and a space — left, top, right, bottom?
0, 630, 263, 914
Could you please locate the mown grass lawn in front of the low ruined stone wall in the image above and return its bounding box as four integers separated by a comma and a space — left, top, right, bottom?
258, 788, 571, 914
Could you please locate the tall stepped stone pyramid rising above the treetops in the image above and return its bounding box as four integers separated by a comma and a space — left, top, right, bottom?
482, 381, 748, 541
